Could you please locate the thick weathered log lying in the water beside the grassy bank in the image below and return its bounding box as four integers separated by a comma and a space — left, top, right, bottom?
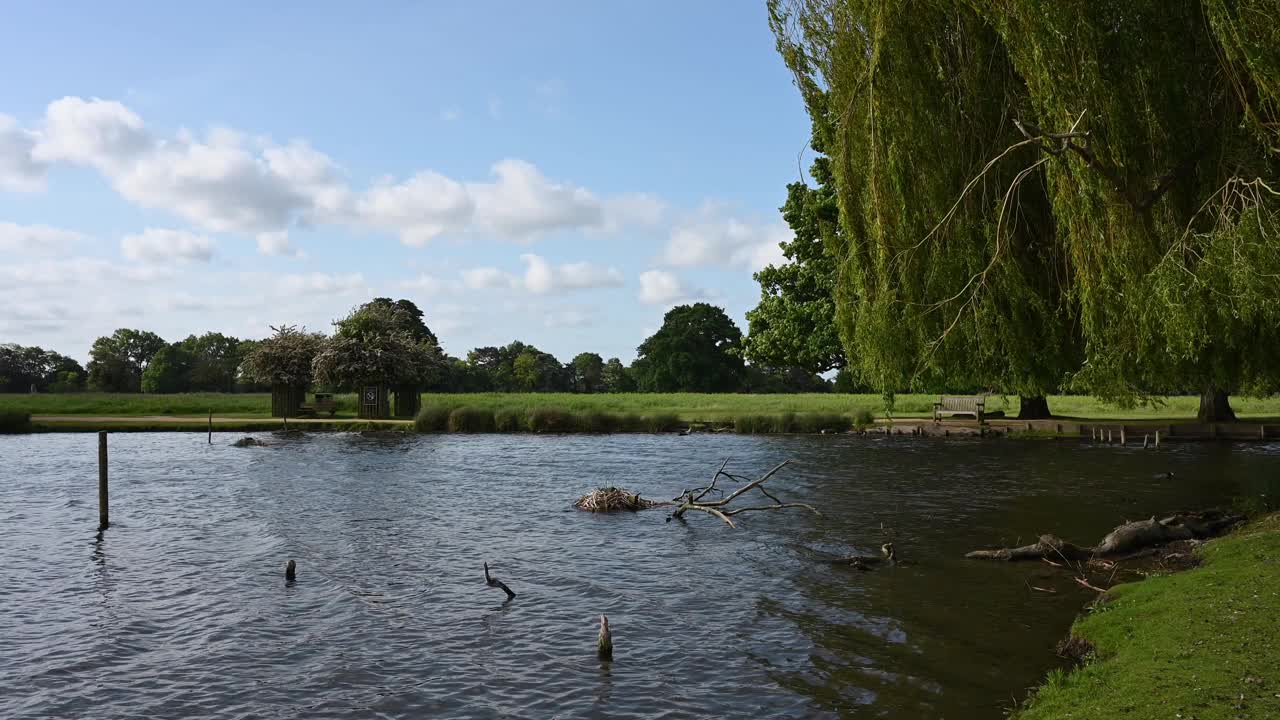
965, 511, 1244, 562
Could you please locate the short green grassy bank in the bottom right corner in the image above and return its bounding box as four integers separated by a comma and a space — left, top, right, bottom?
1016, 514, 1280, 720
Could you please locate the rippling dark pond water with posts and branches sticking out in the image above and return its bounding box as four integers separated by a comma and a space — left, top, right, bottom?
0, 433, 1280, 719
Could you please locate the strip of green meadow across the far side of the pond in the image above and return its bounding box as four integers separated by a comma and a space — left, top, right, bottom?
0, 392, 1280, 421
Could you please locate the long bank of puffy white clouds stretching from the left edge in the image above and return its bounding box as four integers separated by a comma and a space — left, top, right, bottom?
0, 95, 664, 255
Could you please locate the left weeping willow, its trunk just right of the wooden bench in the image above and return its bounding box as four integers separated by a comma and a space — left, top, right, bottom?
771, 0, 1082, 416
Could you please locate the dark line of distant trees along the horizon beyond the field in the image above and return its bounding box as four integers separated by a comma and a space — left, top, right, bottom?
0, 297, 861, 393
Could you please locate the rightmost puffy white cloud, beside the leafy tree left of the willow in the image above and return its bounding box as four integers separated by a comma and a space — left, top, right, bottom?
662, 204, 792, 272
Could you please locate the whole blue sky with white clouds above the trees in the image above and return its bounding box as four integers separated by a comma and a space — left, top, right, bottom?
0, 0, 809, 361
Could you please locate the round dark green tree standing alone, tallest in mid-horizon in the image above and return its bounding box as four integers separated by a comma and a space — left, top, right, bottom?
631, 302, 744, 392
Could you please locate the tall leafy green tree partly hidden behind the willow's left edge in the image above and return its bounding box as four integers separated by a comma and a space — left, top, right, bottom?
742, 140, 846, 373
